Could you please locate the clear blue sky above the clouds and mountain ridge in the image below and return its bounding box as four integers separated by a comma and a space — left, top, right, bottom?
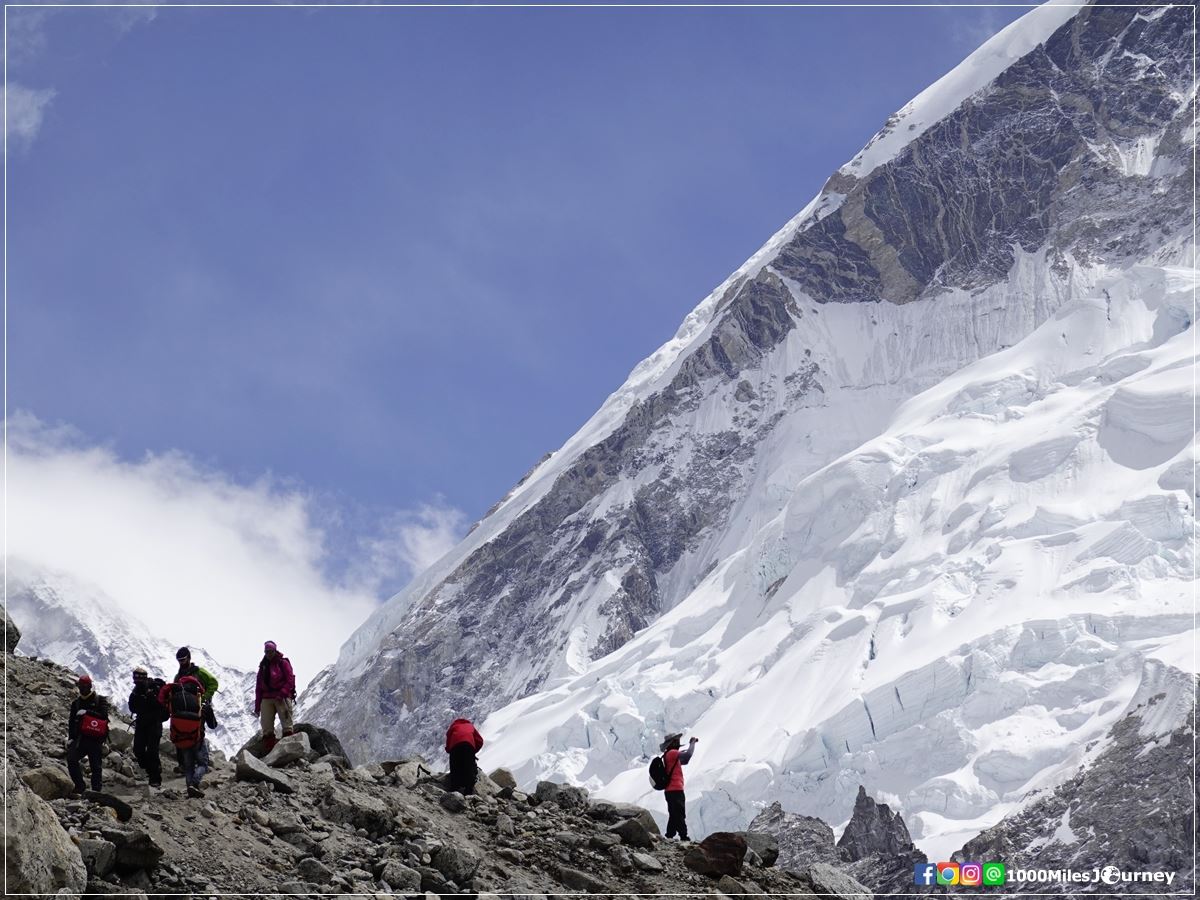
7, 7, 1024, 643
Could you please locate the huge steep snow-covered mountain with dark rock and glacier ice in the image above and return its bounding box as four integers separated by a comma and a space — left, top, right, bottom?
304, 4, 1196, 858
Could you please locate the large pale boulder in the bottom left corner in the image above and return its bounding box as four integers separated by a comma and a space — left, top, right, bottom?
4, 773, 88, 894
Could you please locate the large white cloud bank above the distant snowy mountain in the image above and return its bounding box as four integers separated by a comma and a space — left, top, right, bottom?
6, 414, 463, 691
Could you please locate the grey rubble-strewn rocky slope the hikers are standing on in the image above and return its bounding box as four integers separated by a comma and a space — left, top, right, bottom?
5, 633, 906, 899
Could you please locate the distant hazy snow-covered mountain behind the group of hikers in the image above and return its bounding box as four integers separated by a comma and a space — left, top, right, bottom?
5, 557, 258, 756
